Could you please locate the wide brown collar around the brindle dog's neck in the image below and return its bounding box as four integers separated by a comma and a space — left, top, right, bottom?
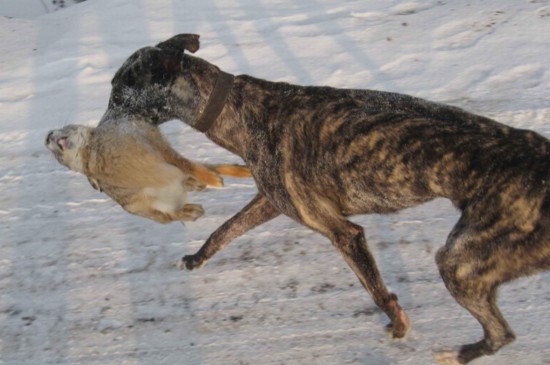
193, 70, 235, 133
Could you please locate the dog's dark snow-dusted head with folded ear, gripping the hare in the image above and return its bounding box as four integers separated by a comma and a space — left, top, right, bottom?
104, 34, 209, 124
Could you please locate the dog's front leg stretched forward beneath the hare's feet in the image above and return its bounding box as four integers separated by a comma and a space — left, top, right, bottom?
178, 193, 281, 271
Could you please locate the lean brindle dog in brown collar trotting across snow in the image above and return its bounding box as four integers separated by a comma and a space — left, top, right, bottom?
99, 34, 550, 364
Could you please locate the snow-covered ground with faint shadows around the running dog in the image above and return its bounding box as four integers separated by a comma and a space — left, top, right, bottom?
0, 0, 550, 365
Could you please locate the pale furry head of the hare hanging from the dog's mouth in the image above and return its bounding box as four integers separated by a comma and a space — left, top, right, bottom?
46, 124, 94, 172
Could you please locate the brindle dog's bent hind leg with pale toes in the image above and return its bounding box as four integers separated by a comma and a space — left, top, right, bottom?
434, 218, 519, 365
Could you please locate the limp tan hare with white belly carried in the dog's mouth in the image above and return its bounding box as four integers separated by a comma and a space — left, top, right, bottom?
46, 120, 250, 223
